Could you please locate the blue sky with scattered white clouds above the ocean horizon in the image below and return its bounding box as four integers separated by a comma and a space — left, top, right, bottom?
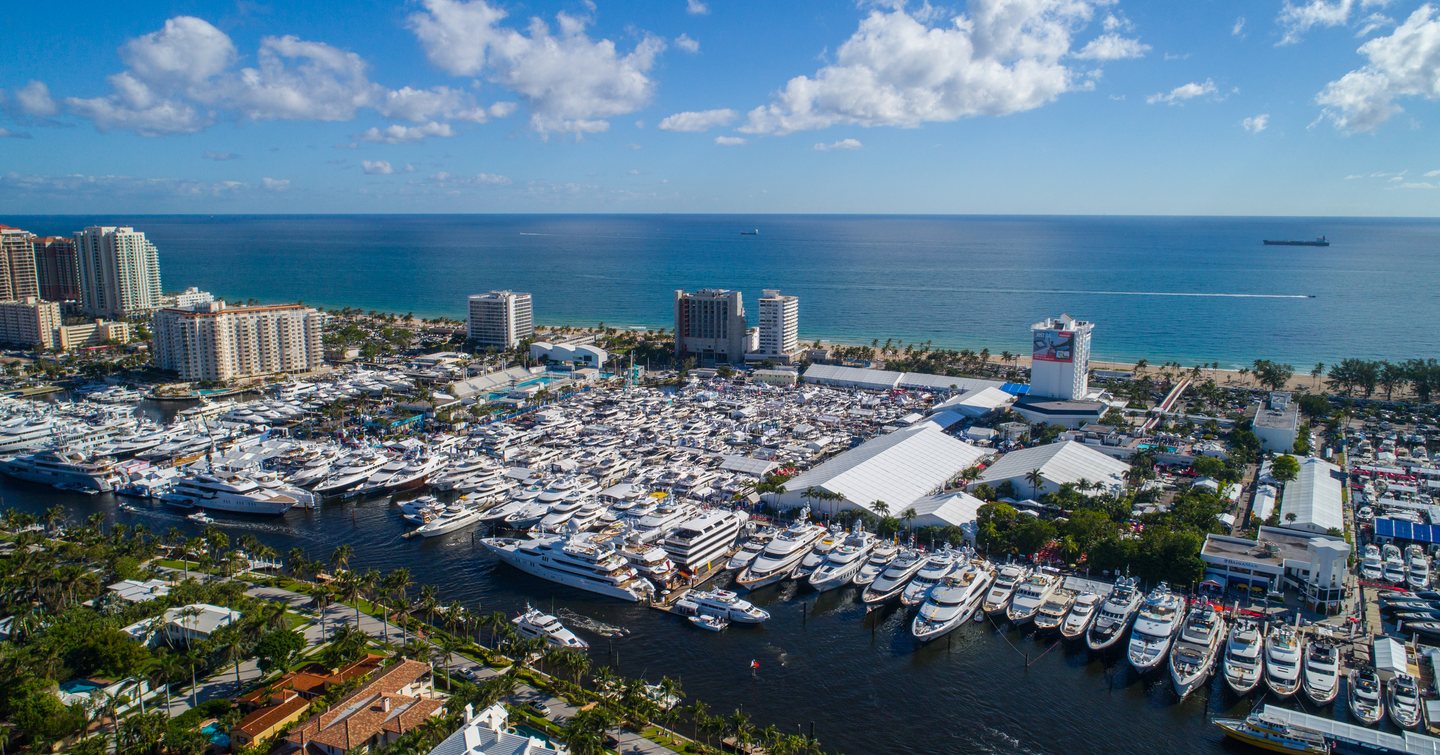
0, 0, 1440, 216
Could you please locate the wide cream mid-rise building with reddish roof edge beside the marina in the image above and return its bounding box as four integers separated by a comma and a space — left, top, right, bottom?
153, 301, 325, 382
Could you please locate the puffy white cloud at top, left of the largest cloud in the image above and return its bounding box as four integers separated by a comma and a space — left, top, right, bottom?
409, 0, 665, 134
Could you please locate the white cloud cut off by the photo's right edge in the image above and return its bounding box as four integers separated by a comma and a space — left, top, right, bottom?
1315, 4, 1440, 133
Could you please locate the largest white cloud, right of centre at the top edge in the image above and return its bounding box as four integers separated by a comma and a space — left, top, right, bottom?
742, 0, 1111, 134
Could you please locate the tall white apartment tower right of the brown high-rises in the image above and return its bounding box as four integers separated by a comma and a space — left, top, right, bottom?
75, 226, 160, 320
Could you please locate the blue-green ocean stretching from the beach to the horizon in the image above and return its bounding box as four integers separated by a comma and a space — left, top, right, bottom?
14, 215, 1440, 369
